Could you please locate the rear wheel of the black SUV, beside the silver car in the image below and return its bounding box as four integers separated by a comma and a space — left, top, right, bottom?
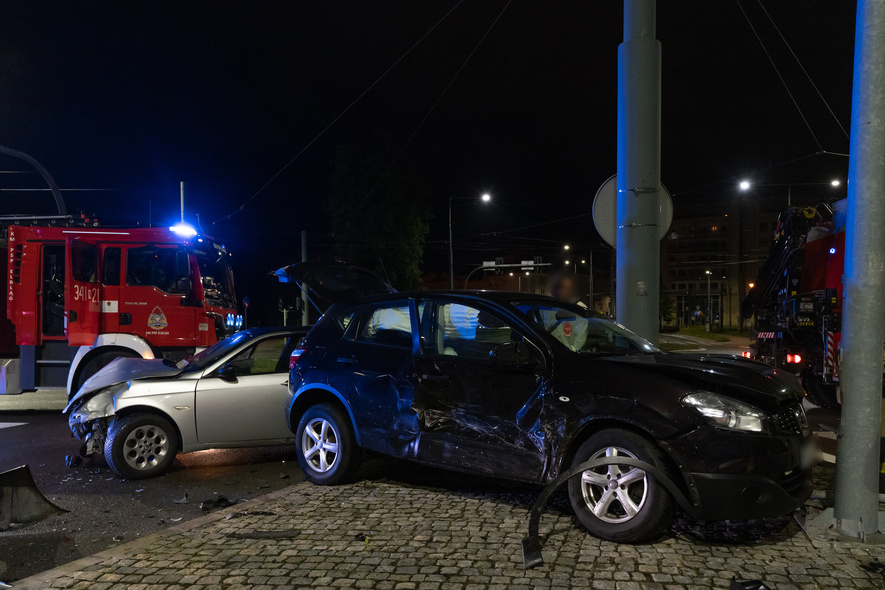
295, 404, 362, 486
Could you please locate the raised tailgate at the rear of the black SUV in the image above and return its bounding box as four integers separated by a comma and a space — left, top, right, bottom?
273, 262, 396, 313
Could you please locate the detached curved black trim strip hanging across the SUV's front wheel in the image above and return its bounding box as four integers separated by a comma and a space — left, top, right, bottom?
522, 457, 695, 570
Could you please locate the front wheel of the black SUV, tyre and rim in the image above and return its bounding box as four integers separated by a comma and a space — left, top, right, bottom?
568, 428, 675, 543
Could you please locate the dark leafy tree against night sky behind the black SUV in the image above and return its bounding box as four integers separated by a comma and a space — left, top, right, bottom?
326, 145, 431, 290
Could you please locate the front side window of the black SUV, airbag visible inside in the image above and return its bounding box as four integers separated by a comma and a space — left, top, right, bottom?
419, 301, 523, 361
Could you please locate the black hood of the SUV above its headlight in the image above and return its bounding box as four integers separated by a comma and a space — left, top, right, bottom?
603, 353, 805, 411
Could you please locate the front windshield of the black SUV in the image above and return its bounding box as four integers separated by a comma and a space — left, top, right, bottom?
511, 301, 662, 355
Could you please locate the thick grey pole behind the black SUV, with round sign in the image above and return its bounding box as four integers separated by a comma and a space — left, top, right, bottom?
616, 0, 661, 343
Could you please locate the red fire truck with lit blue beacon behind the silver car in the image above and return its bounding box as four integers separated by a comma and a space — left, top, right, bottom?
0, 216, 242, 397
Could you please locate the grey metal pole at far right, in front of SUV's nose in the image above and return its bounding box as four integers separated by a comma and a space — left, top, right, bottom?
834, 0, 885, 539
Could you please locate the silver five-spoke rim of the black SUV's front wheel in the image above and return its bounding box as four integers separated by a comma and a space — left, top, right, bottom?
581, 447, 648, 524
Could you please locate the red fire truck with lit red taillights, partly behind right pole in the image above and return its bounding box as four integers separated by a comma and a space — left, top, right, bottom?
741, 199, 880, 409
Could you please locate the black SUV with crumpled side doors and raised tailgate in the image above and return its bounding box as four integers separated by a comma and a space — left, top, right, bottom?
277, 263, 815, 542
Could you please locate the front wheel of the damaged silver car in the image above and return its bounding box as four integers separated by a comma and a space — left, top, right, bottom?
104, 413, 178, 479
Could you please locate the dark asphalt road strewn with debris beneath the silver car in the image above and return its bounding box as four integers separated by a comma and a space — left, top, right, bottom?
0, 412, 304, 583
